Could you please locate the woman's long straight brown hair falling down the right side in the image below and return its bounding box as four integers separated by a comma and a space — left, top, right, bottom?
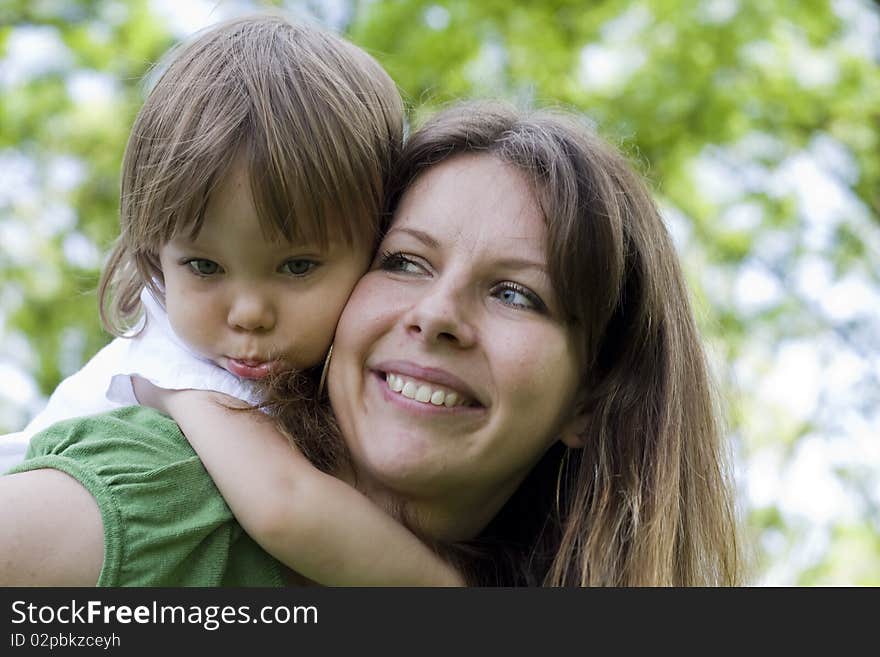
386, 103, 741, 586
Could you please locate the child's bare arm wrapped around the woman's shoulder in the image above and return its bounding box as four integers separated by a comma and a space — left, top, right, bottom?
135, 379, 464, 586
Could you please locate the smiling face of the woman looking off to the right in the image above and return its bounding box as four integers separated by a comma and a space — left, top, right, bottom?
330, 154, 580, 540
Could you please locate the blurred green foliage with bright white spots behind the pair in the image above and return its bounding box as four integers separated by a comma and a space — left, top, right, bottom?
0, 0, 880, 584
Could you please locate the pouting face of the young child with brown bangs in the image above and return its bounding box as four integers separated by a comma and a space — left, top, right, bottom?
159, 160, 371, 379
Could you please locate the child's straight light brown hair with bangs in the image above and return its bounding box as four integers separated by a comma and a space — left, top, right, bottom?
99, 15, 403, 335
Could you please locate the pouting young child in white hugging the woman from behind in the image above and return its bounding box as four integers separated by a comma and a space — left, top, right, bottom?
1, 16, 461, 585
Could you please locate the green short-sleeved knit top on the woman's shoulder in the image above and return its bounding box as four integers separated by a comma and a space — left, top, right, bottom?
10, 406, 284, 586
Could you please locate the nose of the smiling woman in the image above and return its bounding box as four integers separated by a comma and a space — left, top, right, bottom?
404, 283, 476, 347
